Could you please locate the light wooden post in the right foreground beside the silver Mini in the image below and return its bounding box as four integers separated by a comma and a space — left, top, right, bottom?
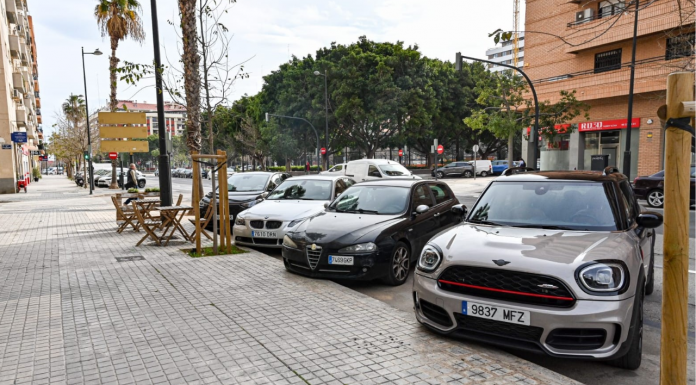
660, 72, 694, 385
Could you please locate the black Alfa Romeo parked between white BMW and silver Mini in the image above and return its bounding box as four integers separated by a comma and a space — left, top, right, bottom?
283, 180, 466, 286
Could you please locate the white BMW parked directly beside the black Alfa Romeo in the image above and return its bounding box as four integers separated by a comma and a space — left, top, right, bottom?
232, 175, 355, 248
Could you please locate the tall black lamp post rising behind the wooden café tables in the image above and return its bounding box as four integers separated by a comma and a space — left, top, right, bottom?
150, 0, 171, 206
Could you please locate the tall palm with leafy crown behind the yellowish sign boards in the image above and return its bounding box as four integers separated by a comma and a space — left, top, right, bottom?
94, 0, 145, 189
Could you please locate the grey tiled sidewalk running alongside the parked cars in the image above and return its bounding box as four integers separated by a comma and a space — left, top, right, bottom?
0, 177, 576, 385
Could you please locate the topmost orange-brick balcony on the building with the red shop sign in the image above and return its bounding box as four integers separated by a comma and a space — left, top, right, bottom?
563, 0, 694, 53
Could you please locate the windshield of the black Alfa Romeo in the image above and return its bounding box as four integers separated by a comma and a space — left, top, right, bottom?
329, 186, 409, 215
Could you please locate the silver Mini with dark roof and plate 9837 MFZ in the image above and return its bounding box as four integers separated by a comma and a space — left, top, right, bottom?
413, 169, 662, 369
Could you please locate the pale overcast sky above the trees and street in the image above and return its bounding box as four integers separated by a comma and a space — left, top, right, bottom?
28, 0, 524, 133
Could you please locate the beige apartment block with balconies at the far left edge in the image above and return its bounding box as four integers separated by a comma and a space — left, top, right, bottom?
0, 0, 43, 194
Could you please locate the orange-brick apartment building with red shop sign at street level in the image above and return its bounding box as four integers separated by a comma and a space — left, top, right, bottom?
523, 0, 694, 178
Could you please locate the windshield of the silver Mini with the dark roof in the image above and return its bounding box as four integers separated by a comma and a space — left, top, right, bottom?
468, 181, 618, 231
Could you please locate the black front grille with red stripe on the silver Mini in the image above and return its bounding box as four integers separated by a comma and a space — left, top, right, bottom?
438, 266, 575, 307
